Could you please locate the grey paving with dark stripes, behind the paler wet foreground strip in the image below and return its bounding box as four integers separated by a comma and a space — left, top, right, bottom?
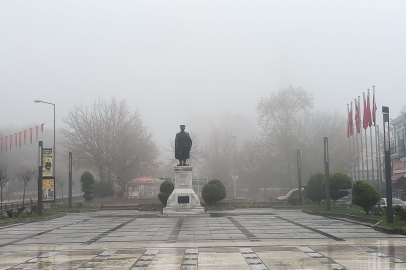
0, 210, 403, 247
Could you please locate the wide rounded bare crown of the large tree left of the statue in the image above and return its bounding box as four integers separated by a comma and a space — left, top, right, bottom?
61, 98, 158, 196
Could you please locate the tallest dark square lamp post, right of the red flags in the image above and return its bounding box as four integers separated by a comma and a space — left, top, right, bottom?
382, 106, 393, 223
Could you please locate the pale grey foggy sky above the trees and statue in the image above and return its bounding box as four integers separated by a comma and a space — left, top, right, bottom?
0, 0, 406, 153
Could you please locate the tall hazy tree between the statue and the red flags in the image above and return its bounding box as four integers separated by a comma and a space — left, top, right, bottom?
257, 86, 313, 188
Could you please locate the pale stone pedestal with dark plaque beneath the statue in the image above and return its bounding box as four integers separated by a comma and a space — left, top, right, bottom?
163, 166, 204, 216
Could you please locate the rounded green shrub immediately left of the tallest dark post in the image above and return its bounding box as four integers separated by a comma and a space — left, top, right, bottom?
352, 180, 381, 215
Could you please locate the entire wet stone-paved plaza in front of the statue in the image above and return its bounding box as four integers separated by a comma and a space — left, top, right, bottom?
0, 209, 406, 270
